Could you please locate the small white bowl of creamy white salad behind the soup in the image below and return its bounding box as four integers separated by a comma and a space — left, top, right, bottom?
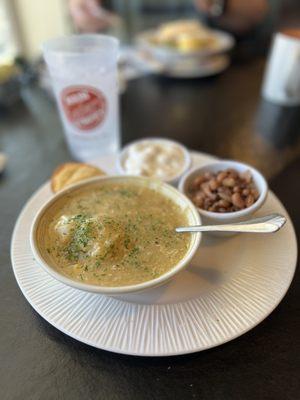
117, 138, 191, 185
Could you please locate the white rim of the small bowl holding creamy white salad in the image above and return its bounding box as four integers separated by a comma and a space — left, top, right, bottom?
116, 136, 192, 184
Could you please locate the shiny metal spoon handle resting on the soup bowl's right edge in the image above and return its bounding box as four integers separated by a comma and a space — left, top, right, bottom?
176, 214, 286, 233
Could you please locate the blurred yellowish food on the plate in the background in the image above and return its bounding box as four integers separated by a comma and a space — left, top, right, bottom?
152, 20, 217, 52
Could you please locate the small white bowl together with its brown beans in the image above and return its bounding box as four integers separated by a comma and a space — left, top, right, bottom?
178, 160, 268, 233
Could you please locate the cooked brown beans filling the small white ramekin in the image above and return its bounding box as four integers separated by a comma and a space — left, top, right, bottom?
188, 169, 259, 213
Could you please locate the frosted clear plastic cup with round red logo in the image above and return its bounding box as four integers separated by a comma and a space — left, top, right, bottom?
43, 34, 120, 161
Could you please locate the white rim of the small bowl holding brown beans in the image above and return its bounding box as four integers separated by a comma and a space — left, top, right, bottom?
178, 159, 268, 220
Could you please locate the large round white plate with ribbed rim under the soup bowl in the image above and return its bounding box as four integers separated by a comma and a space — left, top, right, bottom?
11, 154, 297, 356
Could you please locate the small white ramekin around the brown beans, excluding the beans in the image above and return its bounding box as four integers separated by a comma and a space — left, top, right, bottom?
178, 160, 268, 236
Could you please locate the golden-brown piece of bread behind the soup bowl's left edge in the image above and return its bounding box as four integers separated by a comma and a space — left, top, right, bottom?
51, 162, 106, 193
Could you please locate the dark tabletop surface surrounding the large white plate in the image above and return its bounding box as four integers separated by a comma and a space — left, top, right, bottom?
0, 60, 300, 400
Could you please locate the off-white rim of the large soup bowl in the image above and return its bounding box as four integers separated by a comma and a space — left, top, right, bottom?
30, 175, 202, 295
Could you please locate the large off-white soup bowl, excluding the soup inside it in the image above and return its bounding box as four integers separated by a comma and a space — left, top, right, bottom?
30, 176, 201, 295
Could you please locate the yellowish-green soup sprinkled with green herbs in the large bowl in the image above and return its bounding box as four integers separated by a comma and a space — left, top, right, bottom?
41, 181, 191, 286
